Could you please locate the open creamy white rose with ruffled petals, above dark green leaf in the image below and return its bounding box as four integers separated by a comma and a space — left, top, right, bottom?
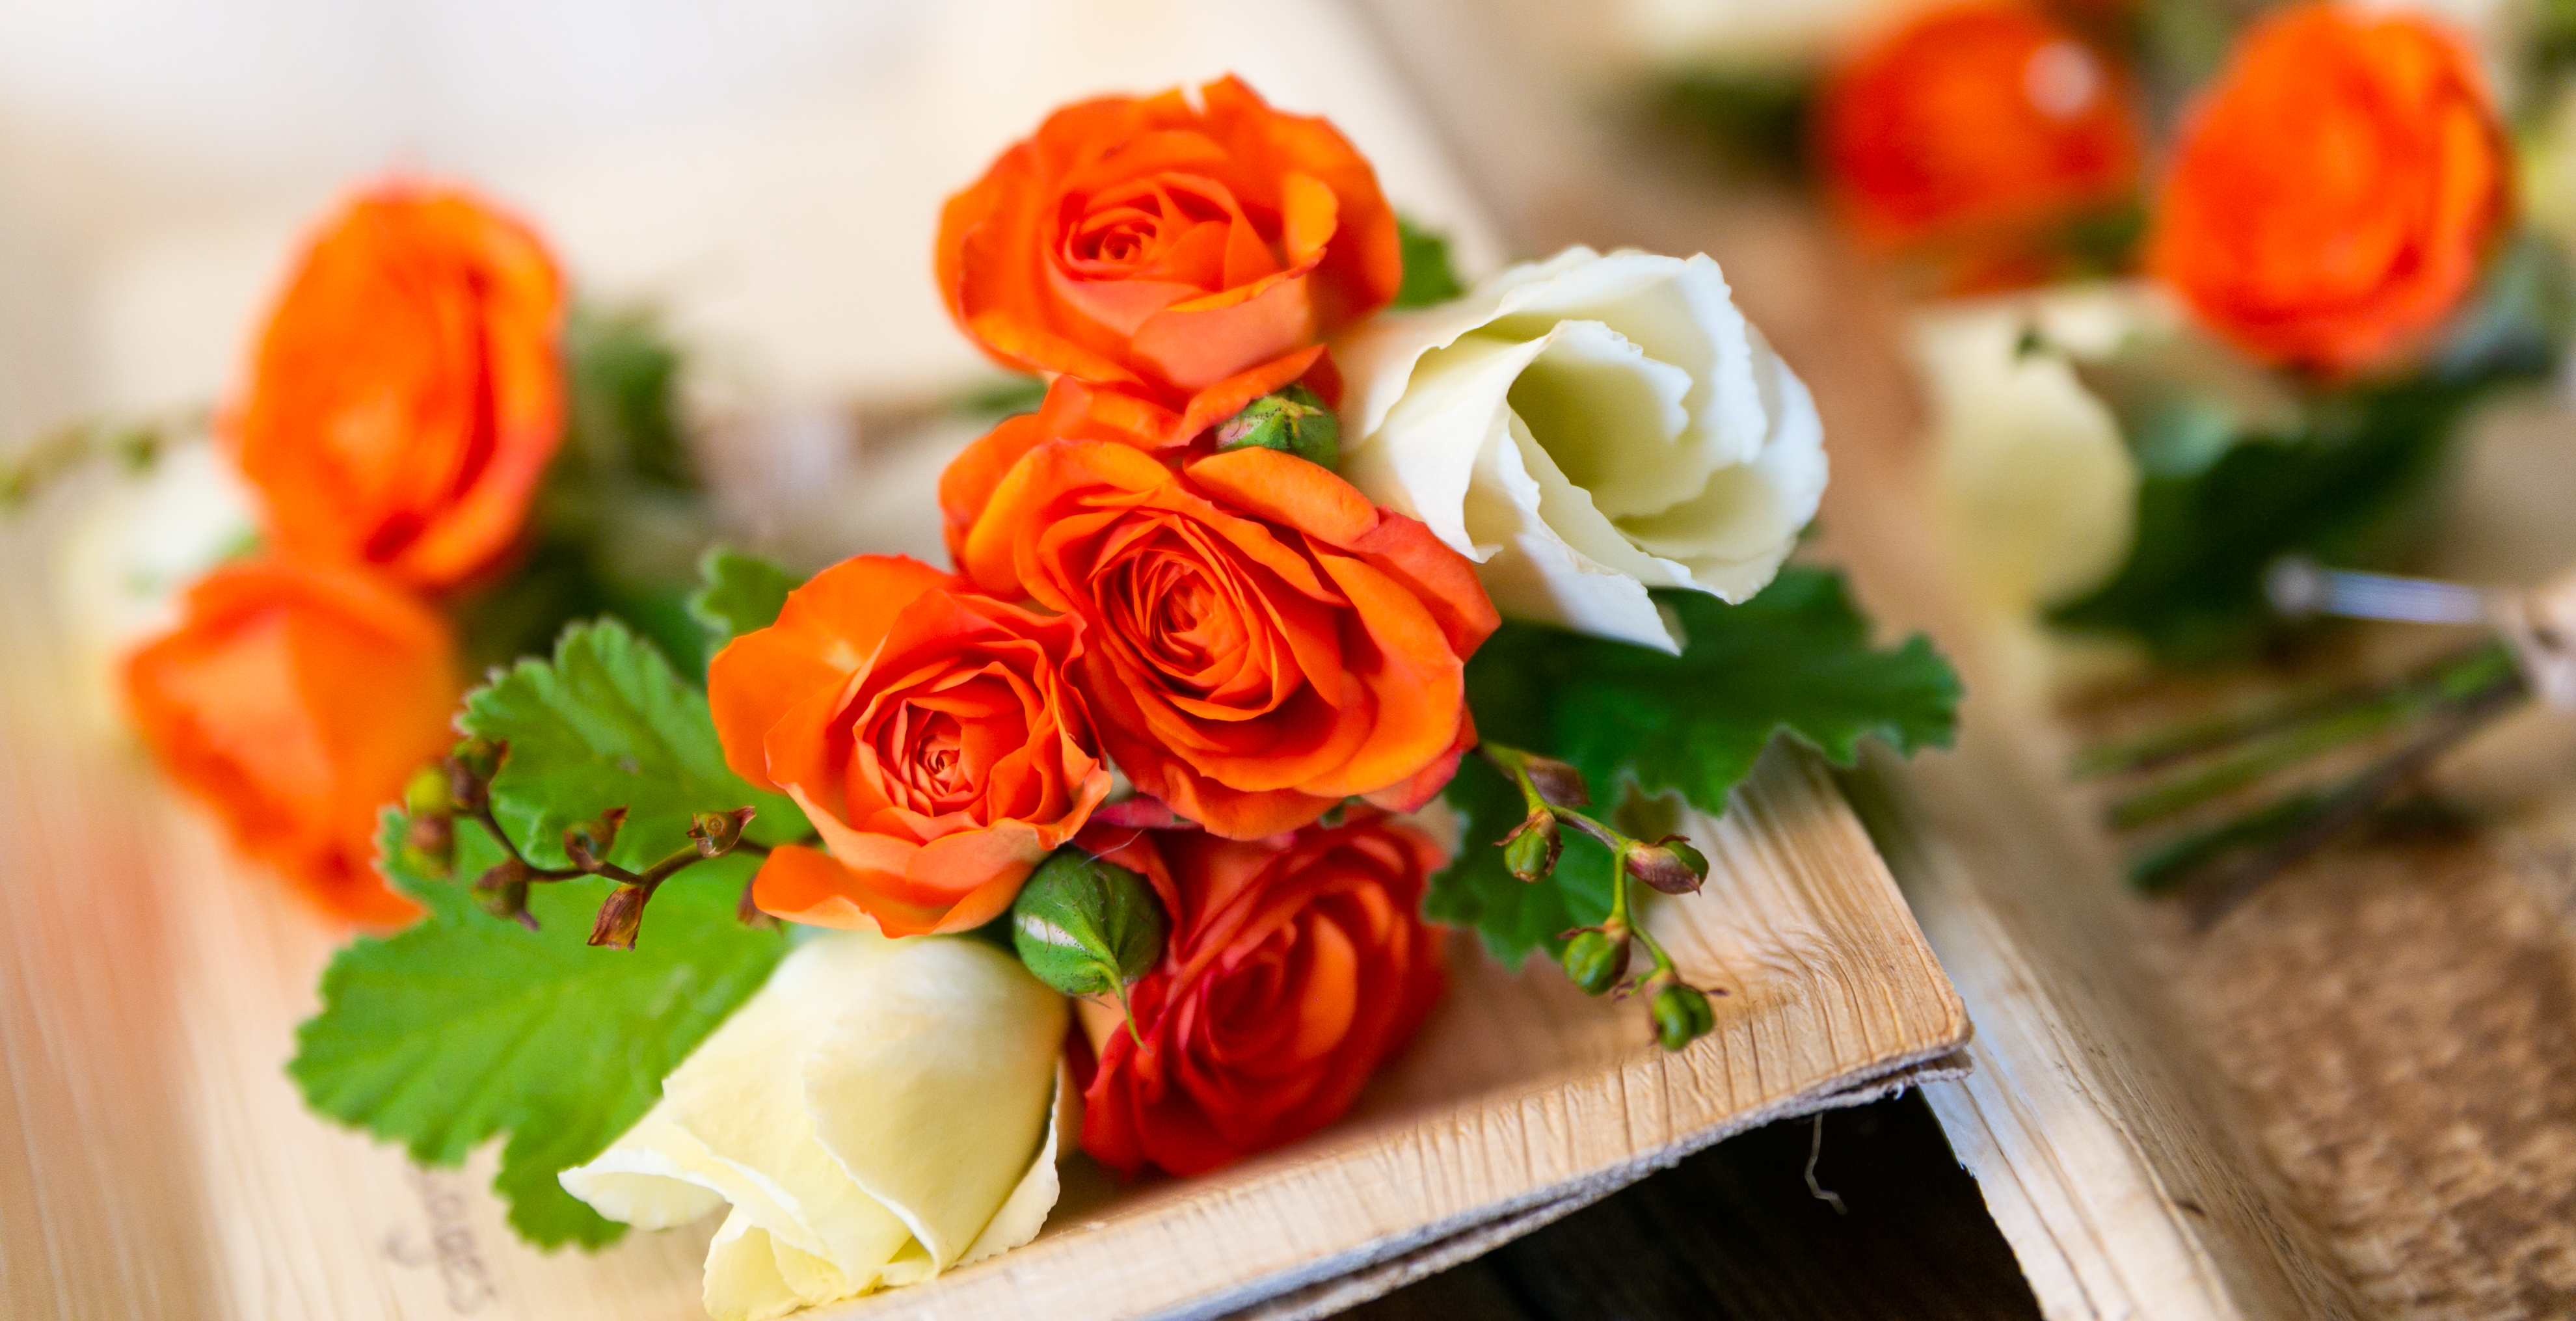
1334, 247, 1827, 652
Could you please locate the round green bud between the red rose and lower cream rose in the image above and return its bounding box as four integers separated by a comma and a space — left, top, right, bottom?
1010, 847, 1167, 996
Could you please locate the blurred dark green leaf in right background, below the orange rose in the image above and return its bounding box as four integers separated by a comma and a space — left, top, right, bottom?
2050, 379, 2488, 664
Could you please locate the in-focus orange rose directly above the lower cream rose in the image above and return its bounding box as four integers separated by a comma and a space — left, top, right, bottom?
706, 556, 1110, 935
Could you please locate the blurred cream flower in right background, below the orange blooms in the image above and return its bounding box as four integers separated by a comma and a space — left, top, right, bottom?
1914, 286, 2158, 613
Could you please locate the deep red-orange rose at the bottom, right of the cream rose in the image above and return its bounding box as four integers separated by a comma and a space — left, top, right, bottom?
1082, 808, 1445, 1174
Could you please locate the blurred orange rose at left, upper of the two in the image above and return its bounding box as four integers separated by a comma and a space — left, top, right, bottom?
234, 183, 564, 590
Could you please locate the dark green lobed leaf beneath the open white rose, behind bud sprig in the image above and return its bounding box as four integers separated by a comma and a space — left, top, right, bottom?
1425, 567, 1961, 961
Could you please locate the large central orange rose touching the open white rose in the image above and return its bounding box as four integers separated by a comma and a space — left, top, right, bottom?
961, 440, 1499, 840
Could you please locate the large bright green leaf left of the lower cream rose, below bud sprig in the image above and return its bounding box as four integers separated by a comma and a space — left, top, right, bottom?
286, 811, 786, 1246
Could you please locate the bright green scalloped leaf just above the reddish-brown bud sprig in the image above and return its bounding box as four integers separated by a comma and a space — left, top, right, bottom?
456, 620, 809, 875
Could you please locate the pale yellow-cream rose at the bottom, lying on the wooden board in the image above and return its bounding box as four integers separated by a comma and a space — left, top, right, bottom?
561, 932, 1066, 1321
